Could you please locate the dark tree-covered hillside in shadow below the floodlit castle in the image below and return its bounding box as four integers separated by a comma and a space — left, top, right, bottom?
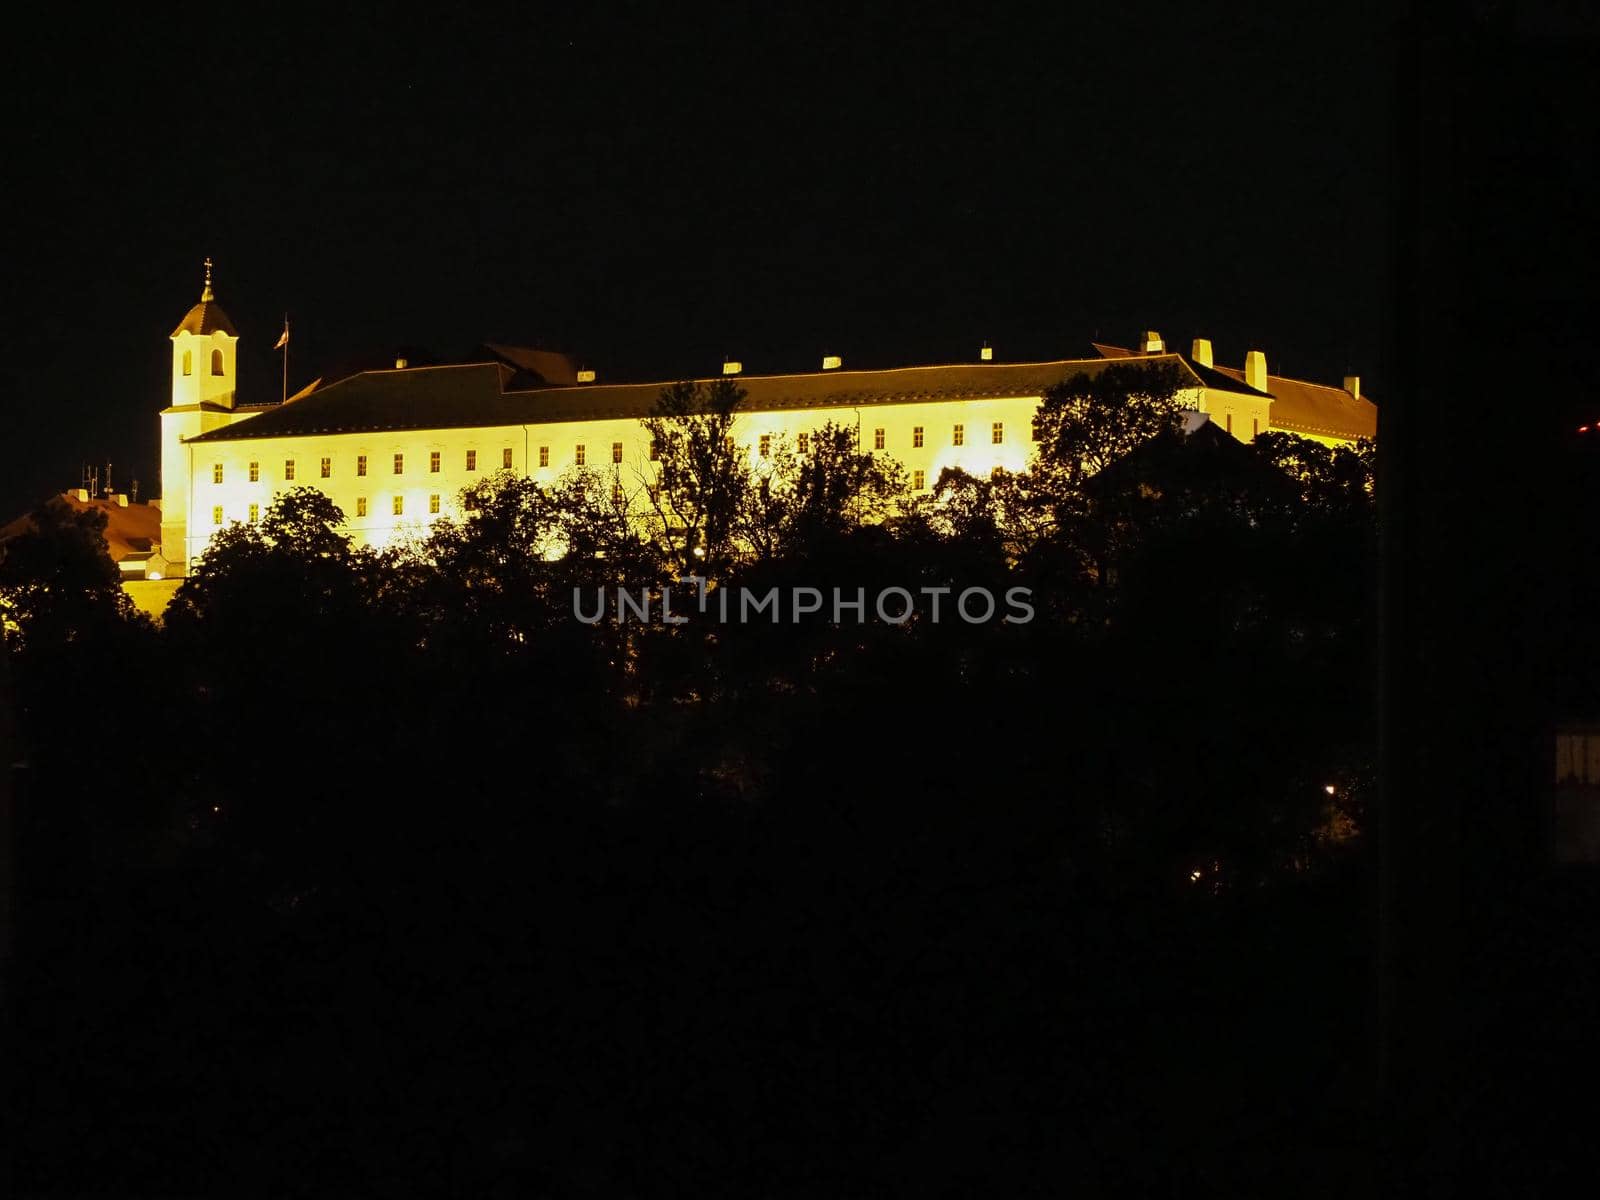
5, 395, 1374, 1197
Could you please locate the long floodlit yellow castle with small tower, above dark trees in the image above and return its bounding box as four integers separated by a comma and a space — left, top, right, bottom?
160, 261, 1376, 574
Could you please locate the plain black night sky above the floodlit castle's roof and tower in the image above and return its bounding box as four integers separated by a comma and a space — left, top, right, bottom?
0, 3, 1394, 515
